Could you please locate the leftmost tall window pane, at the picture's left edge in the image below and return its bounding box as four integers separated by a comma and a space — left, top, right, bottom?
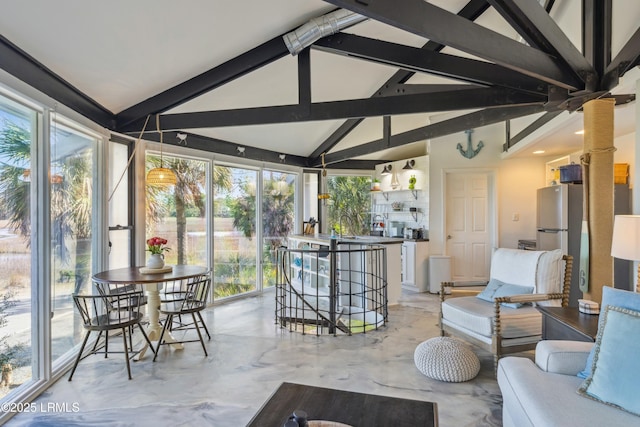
0, 97, 37, 397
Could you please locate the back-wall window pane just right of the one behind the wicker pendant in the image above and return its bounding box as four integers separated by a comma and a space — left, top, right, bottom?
213, 165, 259, 299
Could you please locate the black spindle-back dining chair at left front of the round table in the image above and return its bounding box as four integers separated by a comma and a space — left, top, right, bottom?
69, 291, 155, 381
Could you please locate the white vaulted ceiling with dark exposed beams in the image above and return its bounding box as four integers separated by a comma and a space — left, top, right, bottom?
0, 0, 640, 168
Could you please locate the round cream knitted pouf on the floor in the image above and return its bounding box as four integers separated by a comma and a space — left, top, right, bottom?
413, 337, 480, 383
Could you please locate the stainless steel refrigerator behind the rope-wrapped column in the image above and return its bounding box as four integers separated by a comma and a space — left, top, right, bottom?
536, 184, 632, 307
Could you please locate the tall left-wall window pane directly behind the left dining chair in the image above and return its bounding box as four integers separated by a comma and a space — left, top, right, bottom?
49, 121, 98, 361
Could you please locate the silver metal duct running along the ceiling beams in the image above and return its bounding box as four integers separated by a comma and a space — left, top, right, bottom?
282, 9, 368, 56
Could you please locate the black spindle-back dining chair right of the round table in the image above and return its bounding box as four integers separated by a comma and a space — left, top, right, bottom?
153, 275, 211, 362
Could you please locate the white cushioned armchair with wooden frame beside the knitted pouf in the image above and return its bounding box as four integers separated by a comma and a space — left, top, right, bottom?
440, 248, 573, 368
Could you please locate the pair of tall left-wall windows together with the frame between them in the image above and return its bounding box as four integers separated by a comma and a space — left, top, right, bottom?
0, 93, 98, 404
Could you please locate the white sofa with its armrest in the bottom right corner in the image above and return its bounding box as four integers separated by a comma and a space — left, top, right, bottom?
498, 340, 640, 427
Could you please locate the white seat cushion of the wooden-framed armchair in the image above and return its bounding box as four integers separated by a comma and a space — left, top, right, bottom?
442, 296, 542, 338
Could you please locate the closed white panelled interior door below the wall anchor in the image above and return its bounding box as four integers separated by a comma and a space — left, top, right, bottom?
445, 173, 493, 282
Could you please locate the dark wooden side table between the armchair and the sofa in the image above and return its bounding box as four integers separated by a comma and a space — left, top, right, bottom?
538, 306, 599, 342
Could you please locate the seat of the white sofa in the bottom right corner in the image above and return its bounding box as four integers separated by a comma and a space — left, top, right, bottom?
497, 357, 639, 427
